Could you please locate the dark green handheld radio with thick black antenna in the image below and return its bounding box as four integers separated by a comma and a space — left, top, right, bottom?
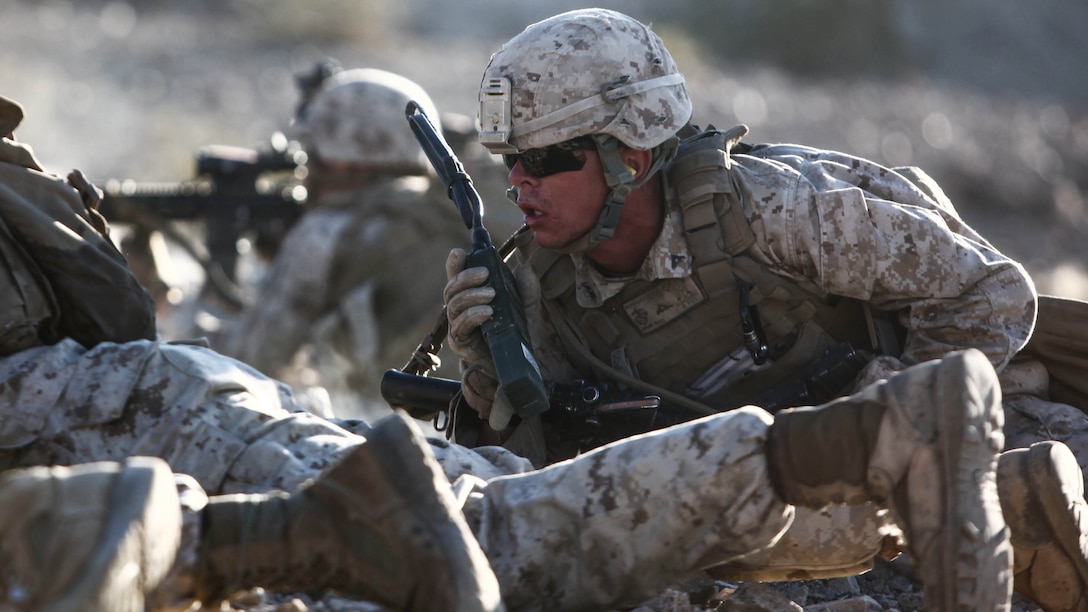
405, 101, 549, 429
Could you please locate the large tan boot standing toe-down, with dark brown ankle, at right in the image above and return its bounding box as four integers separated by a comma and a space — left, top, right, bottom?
767, 350, 1012, 612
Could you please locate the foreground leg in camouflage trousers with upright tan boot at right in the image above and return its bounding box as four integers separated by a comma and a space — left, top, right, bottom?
466, 352, 1012, 610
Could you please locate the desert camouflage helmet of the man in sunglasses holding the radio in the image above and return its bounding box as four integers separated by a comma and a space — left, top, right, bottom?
479, 9, 691, 152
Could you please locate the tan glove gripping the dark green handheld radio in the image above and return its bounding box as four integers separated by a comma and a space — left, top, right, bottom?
443, 248, 541, 430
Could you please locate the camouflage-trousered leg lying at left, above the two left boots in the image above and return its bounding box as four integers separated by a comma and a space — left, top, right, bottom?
0, 342, 364, 494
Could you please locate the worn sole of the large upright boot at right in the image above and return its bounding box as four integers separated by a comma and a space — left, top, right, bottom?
919, 353, 1012, 611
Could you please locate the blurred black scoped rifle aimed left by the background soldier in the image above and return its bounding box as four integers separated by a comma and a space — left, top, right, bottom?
99, 133, 306, 309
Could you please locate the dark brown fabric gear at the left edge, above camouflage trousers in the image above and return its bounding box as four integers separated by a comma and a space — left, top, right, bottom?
0, 98, 156, 356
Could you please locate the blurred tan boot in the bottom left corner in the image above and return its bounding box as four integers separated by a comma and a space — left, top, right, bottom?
0, 457, 182, 612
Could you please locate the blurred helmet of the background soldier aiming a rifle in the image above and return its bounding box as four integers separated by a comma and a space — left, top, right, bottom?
290, 69, 442, 174
